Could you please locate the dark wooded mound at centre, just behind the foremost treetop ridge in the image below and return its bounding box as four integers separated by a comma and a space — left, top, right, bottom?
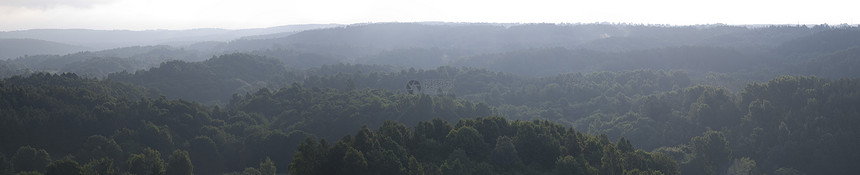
230, 84, 498, 144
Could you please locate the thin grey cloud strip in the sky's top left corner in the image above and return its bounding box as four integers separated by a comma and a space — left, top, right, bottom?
0, 0, 117, 9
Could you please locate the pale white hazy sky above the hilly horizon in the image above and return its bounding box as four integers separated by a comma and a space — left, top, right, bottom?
0, 0, 860, 31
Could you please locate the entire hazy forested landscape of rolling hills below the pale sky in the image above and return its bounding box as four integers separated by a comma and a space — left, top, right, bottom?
0, 23, 860, 175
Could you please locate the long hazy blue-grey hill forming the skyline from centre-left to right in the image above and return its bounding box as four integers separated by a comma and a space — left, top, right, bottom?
210, 23, 840, 68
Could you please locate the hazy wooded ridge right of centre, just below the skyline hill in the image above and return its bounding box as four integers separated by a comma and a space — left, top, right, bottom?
451, 46, 773, 76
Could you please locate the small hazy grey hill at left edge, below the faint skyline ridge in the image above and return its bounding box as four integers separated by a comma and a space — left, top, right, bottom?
0, 39, 88, 60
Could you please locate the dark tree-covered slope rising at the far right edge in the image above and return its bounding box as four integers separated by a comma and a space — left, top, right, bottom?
727, 76, 860, 174
